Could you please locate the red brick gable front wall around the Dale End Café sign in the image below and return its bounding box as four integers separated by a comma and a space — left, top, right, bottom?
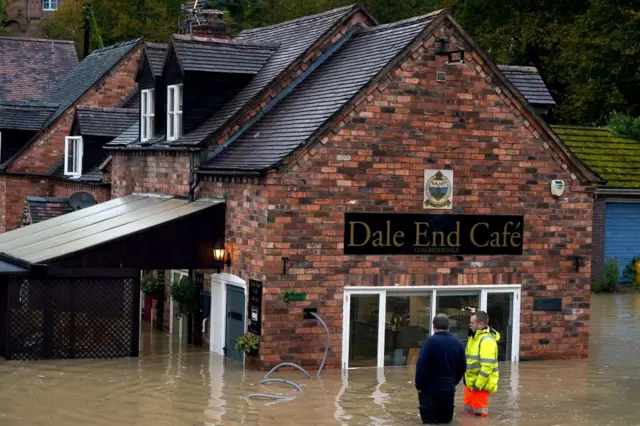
251, 20, 592, 365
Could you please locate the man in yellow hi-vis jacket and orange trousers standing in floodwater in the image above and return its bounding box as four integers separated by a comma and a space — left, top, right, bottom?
464, 311, 500, 417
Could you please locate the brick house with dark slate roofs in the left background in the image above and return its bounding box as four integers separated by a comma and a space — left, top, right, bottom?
0, 39, 143, 231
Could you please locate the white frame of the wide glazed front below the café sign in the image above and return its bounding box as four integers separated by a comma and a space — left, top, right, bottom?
342, 284, 522, 369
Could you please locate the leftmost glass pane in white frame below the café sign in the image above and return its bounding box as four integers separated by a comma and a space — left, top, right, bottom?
349, 294, 380, 367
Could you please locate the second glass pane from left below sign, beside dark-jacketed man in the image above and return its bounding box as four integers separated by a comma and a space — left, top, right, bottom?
384, 293, 431, 366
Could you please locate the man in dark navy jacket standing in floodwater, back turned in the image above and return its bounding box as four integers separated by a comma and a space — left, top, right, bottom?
415, 314, 467, 424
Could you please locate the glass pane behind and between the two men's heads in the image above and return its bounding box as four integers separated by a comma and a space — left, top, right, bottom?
434, 290, 480, 344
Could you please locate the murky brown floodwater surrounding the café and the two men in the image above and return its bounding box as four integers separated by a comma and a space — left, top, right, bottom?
0, 294, 640, 426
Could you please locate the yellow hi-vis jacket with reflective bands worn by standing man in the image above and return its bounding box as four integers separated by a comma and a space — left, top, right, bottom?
464, 327, 500, 393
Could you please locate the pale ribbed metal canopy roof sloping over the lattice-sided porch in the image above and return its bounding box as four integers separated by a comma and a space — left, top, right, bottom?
0, 195, 224, 268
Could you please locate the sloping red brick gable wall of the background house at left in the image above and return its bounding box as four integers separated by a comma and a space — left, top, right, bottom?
8, 47, 141, 174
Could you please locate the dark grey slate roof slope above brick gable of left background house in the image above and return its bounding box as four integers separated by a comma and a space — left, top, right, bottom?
46, 38, 142, 125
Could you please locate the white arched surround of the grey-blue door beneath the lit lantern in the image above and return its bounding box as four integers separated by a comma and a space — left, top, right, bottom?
209, 272, 249, 356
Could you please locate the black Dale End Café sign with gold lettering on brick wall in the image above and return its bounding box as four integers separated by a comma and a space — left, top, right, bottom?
344, 213, 524, 255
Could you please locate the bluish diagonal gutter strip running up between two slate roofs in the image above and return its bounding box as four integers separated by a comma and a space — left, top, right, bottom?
201, 25, 361, 162
